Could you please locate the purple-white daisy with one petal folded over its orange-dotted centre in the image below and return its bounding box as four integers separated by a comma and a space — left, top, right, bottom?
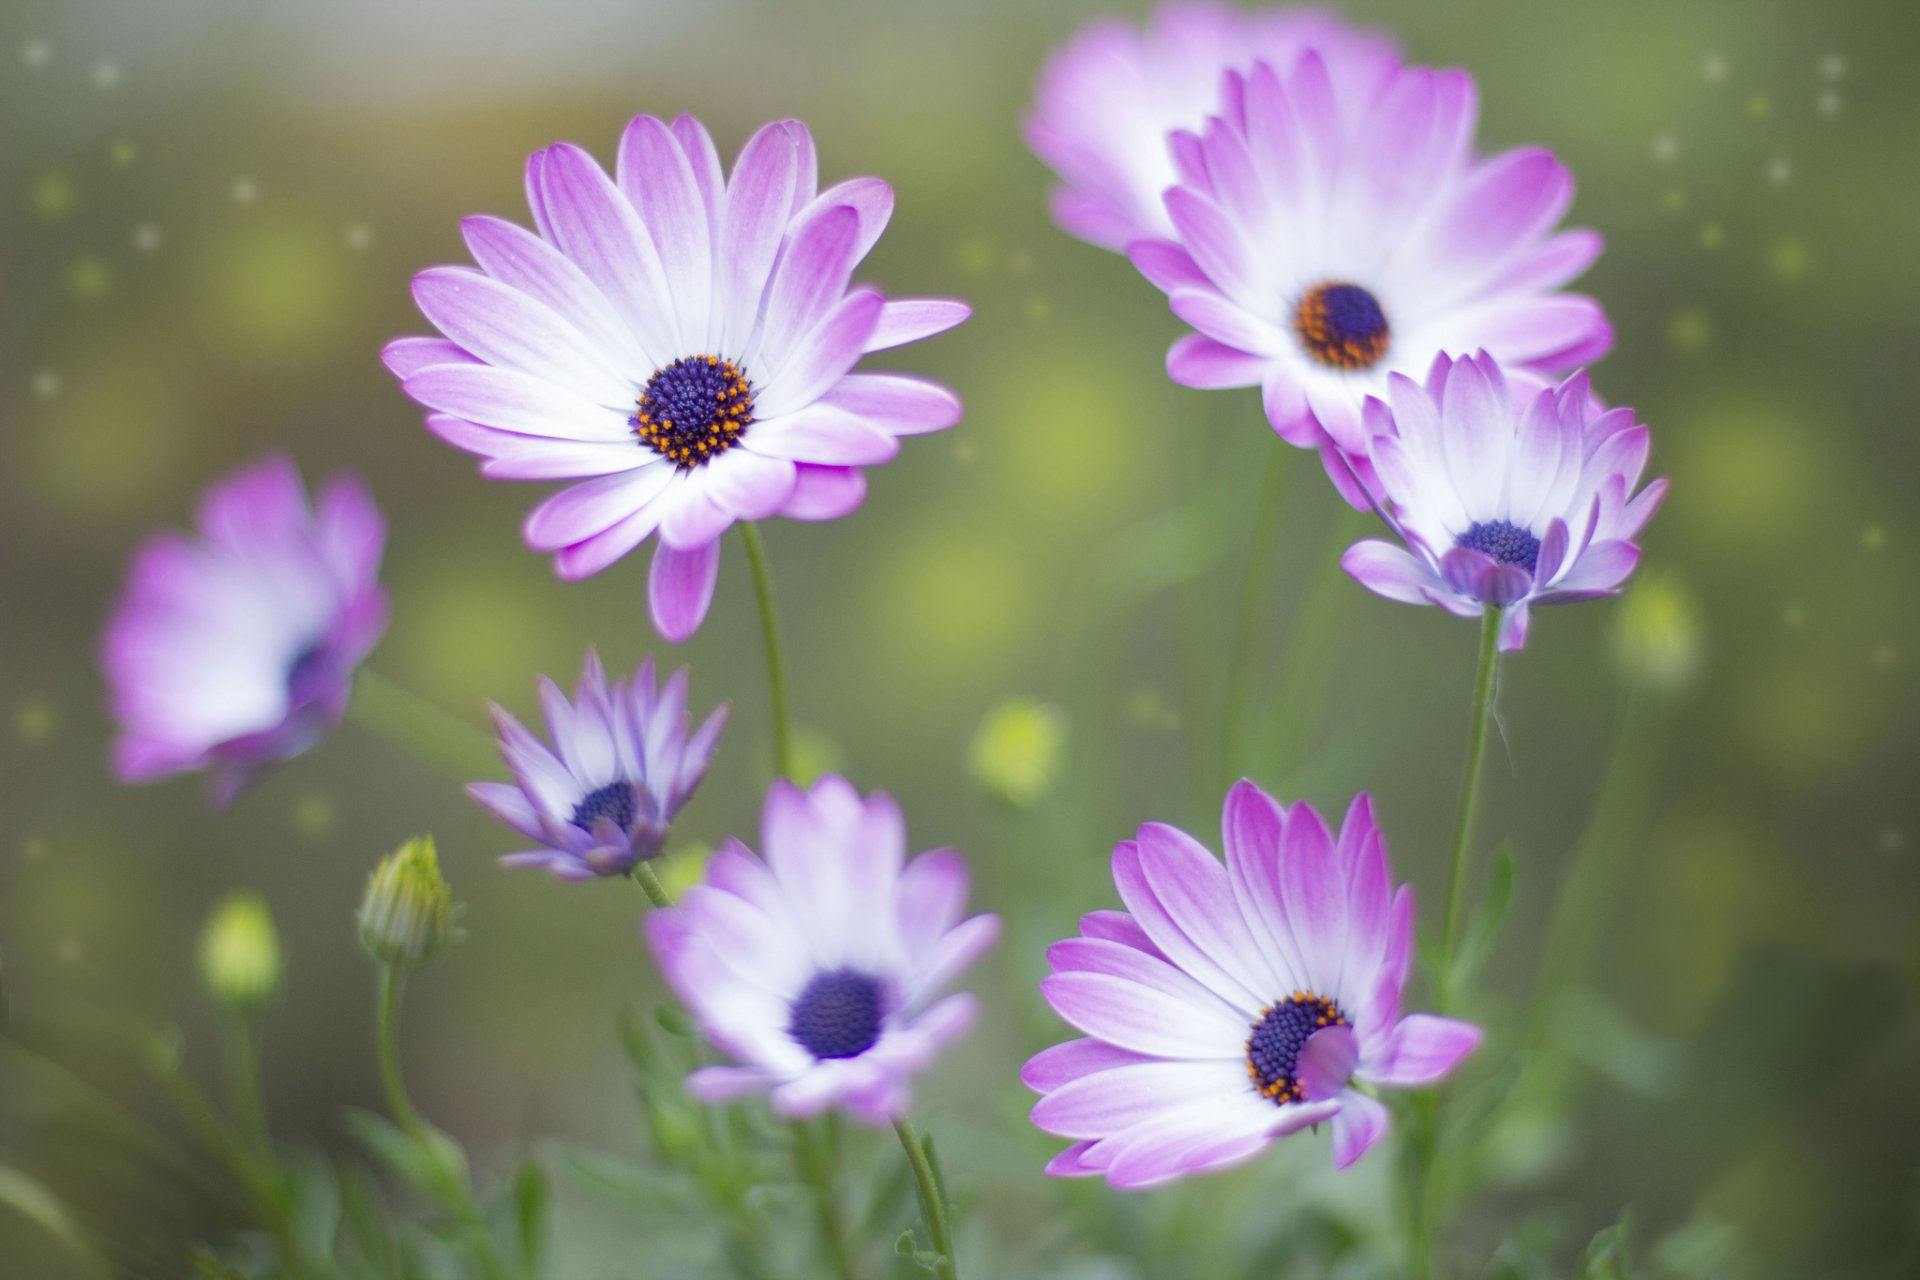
1021, 781, 1480, 1188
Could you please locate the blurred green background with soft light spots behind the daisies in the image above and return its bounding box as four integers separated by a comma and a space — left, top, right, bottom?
0, 0, 1920, 1278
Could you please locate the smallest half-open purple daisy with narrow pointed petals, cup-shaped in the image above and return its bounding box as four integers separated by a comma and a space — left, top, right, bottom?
467, 651, 728, 881
